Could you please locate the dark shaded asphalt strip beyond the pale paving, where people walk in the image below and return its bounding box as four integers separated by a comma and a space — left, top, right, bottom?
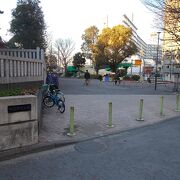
60, 78, 173, 95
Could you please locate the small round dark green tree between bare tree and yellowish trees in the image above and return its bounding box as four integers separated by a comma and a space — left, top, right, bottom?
73, 52, 86, 69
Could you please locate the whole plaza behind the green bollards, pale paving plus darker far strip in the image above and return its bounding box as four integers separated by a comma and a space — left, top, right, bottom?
40, 79, 180, 143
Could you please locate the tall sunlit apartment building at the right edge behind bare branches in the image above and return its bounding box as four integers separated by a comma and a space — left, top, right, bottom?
163, 0, 180, 82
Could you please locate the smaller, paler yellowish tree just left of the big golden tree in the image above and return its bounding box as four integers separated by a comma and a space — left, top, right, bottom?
81, 26, 99, 64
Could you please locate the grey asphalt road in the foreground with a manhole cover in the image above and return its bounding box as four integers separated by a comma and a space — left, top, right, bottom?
0, 118, 180, 180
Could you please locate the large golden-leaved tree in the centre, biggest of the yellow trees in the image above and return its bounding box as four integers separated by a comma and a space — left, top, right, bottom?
98, 25, 137, 72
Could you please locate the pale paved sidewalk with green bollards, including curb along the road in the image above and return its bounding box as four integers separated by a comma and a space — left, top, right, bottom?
0, 85, 180, 161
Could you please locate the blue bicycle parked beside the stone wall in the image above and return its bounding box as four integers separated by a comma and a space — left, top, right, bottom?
43, 92, 65, 113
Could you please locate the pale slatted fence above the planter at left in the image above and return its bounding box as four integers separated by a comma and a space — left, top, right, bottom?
0, 48, 46, 84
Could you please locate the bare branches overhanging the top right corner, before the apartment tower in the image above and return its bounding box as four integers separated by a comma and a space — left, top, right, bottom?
141, 0, 180, 45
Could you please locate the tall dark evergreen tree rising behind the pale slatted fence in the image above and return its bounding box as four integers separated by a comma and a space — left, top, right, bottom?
10, 0, 46, 49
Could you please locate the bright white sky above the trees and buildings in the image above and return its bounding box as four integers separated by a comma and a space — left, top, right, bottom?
0, 0, 155, 50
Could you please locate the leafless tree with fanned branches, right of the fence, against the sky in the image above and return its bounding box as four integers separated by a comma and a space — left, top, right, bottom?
55, 39, 75, 75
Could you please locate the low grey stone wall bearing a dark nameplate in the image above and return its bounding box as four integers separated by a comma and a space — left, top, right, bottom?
0, 95, 38, 150
